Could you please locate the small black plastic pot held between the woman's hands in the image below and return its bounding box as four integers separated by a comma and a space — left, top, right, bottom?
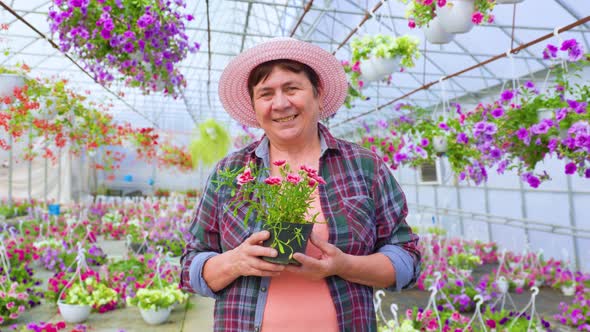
262, 222, 313, 265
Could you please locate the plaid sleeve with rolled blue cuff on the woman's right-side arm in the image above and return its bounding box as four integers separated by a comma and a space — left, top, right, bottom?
372, 161, 421, 291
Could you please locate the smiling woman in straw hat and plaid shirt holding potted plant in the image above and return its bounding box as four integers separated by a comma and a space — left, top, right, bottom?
180, 38, 420, 331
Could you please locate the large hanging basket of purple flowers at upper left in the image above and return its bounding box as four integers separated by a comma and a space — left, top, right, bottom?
48, 0, 199, 97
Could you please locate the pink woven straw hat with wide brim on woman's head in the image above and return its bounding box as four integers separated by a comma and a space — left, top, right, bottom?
219, 37, 348, 127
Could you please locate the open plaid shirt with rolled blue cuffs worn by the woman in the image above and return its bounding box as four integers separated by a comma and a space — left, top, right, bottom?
180, 124, 421, 331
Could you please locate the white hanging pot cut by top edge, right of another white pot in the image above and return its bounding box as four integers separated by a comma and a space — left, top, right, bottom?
436, 0, 475, 33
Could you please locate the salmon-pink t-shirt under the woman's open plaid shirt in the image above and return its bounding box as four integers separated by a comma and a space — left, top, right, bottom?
262, 196, 338, 332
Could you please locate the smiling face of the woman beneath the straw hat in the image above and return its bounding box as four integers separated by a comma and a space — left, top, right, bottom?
252, 67, 320, 144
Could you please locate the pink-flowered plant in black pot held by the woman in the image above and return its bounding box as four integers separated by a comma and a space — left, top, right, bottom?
217, 160, 326, 265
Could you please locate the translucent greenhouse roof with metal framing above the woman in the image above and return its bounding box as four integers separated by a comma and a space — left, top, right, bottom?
0, 0, 590, 133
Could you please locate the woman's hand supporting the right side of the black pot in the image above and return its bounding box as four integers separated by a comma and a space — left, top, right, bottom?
285, 234, 347, 280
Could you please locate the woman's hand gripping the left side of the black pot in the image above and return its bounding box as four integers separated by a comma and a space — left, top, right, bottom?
227, 231, 285, 277
